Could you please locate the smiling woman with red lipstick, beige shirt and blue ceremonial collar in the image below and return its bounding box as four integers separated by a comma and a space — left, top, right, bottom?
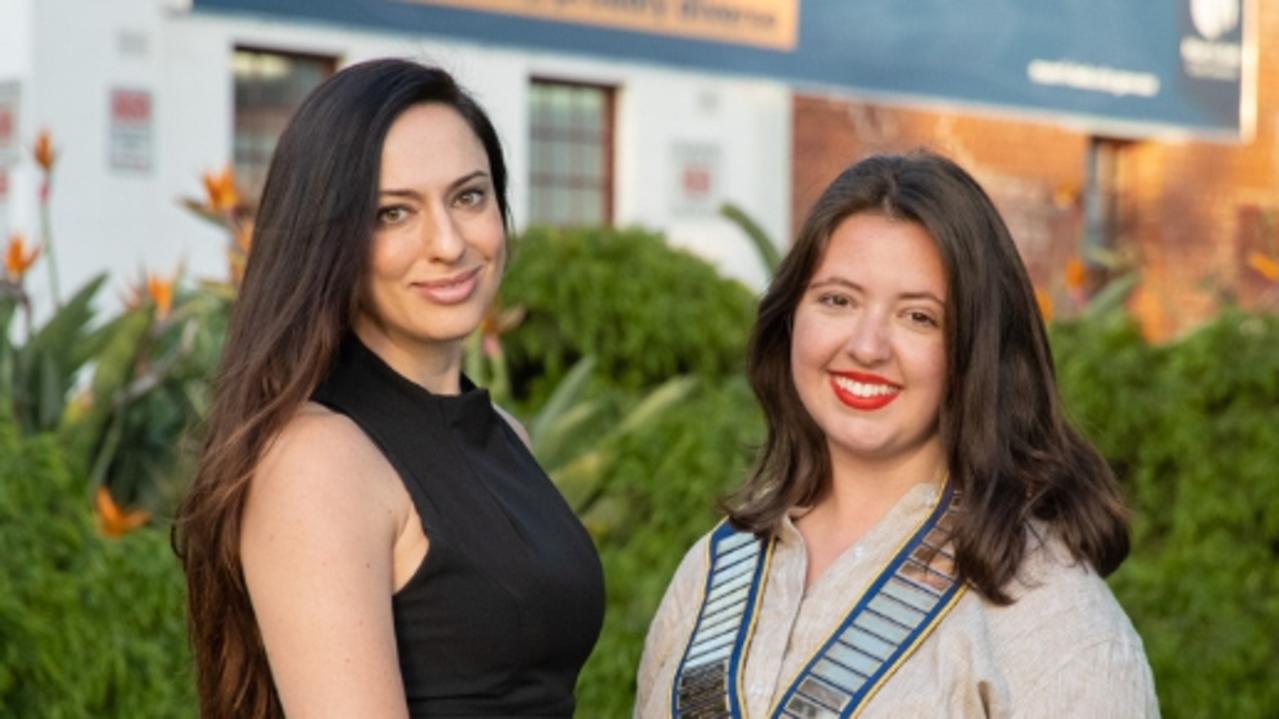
636, 152, 1159, 718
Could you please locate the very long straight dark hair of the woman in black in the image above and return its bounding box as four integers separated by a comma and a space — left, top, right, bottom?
174, 60, 509, 718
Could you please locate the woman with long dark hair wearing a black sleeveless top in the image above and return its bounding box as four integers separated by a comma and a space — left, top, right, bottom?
175, 60, 604, 718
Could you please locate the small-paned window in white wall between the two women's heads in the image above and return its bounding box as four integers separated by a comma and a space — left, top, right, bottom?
528, 79, 613, 226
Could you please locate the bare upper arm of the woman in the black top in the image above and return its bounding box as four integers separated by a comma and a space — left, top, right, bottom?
240, 406, 408, 718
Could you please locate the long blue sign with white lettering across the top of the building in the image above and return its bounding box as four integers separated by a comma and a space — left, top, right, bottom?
194, 0, 1256, 139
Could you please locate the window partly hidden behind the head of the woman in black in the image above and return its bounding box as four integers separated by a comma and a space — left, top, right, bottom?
231, 47, 336, 200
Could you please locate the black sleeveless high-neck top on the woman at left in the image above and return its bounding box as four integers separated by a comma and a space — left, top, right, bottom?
312, 336, 604, 718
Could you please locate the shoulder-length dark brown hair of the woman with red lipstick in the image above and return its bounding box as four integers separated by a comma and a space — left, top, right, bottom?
729, 151, 1128, 604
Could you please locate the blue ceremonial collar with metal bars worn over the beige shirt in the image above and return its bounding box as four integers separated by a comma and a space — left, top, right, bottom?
670, 485, 963, 719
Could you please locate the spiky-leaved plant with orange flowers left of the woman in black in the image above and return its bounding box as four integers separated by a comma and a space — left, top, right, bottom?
0, 266, 230, 510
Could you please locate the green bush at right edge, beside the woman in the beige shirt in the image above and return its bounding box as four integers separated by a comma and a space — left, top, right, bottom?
1054, 304, 1279, 719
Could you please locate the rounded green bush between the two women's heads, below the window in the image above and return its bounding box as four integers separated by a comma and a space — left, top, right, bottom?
501, 228, 755, 398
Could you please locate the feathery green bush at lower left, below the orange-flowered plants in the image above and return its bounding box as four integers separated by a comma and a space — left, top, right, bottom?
0, 418, 194, 719
